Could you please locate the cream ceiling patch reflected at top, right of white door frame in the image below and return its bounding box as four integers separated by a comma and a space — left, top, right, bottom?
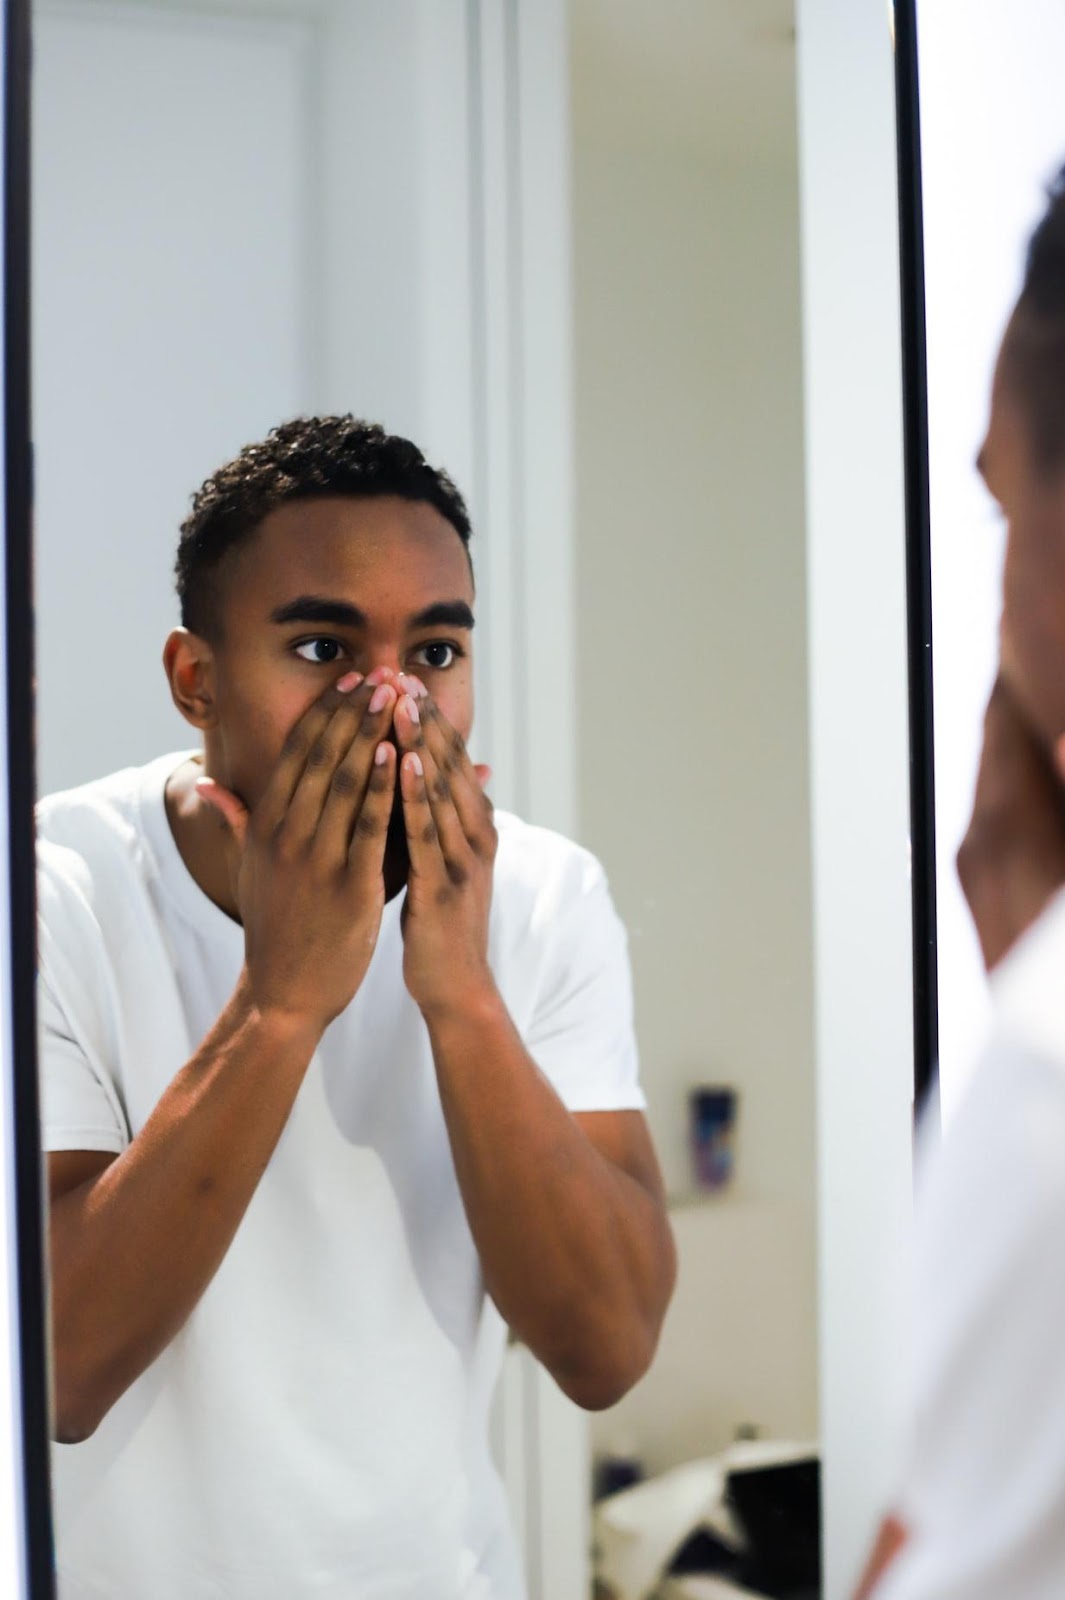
571, 0, 796, 168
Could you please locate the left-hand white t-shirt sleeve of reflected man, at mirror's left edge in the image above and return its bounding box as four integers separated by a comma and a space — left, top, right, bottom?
37, 973, 130, 1154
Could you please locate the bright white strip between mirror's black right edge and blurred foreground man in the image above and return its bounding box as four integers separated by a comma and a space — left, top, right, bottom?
918, 0, 1065, 1122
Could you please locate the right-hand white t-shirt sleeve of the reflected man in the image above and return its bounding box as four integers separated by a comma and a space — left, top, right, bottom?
525, 851, 646, 1110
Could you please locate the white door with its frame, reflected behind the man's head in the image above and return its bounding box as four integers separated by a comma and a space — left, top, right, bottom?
34, 0, 574, 830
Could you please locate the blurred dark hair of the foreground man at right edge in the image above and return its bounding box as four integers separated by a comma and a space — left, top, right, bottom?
1004, 166, 1065, 475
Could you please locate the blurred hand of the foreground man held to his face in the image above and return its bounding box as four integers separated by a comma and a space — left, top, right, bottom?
958, 677, 1065, 971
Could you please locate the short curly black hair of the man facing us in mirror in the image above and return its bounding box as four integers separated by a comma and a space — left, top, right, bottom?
176, 414, 470, 638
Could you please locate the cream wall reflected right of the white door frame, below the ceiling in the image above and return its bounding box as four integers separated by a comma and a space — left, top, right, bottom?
574, 84, 817, 1469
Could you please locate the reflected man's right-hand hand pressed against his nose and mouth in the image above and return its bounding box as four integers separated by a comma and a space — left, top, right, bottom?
395, 685, 496, 1016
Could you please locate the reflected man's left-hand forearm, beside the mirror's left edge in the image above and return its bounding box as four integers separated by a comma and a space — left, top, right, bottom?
50, 987, 317, 1442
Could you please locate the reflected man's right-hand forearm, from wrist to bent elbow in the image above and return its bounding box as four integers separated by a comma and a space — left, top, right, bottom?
427, 994, 673, 1410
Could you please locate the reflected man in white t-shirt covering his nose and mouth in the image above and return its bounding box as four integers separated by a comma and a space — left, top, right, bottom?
38, 418, 673, 1600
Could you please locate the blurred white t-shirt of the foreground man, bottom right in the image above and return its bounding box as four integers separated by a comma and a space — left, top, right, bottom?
876, 894, 1065, 1600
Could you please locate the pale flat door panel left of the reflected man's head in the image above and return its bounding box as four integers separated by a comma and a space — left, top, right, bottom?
34, 5, 310, 794
